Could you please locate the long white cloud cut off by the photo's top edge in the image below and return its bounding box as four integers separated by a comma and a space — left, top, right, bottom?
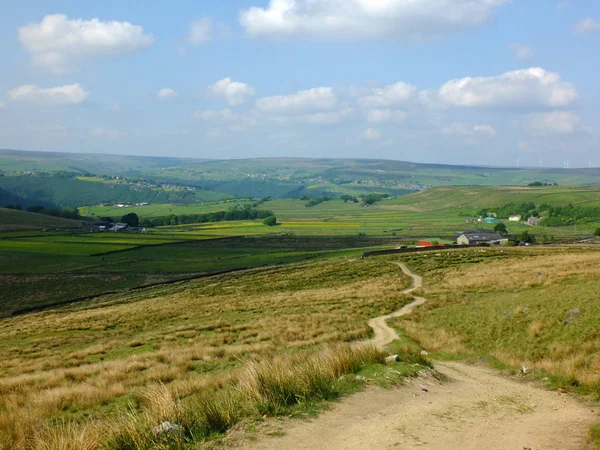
240, 0, 508, 40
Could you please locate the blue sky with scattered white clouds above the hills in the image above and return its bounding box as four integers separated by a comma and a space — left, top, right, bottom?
0, 0, 600, 167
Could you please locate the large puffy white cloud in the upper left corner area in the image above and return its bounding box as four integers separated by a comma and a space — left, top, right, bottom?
19, 14, 154, 73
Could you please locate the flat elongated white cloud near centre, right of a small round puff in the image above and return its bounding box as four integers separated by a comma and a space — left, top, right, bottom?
256, 87, 337, 114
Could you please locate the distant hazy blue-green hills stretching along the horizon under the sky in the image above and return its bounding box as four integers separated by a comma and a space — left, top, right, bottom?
0, 150, 600, 193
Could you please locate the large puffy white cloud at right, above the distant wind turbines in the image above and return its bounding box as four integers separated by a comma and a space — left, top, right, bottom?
428, 67, 577, 108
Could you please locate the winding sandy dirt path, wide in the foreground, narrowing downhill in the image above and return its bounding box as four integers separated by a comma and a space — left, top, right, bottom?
244, 264, 598, 450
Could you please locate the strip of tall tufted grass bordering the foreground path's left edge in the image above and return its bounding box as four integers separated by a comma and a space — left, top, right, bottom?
25, 344, 385, 450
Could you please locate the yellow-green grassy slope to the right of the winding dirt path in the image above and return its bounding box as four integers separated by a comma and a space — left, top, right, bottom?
396, 248, 600, 388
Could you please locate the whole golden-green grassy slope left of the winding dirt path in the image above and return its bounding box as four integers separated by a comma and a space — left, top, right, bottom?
0, 258, 422, 450
